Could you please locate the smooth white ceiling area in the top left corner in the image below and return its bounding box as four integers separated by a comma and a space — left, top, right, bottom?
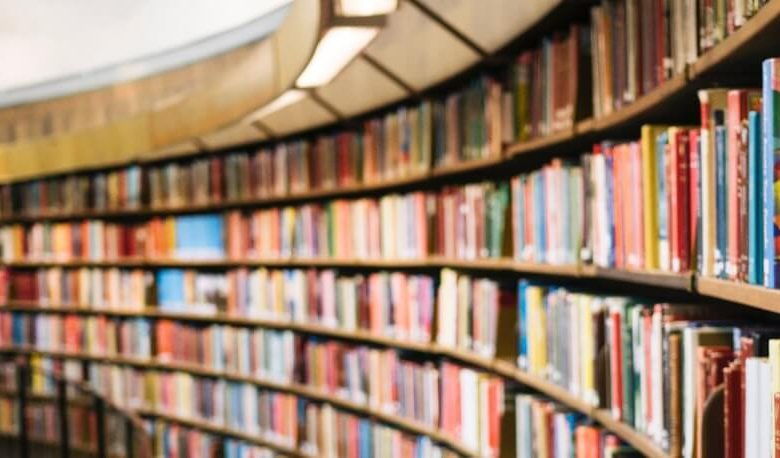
0, 0, 292, 95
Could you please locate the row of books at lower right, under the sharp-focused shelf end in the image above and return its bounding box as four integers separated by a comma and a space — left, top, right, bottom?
518, 282, 780, 457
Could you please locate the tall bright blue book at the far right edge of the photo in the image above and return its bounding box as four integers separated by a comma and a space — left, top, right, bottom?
761, 59, 780, 288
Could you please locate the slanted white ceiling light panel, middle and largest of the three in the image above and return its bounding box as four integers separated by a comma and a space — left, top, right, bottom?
296, 27, 379, 88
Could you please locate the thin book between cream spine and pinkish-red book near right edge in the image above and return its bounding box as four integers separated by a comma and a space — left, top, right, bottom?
715, 121, 728, 278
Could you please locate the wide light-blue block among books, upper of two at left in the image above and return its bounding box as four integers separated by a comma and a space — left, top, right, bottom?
176, 214, 225, 259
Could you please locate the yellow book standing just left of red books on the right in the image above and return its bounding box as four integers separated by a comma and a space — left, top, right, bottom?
642, 125, 666, 269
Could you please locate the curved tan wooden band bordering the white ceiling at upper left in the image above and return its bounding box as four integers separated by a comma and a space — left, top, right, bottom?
0, 0, 322, 181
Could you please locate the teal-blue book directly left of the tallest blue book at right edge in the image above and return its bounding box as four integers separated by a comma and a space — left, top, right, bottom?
748, 111, 764, 285
